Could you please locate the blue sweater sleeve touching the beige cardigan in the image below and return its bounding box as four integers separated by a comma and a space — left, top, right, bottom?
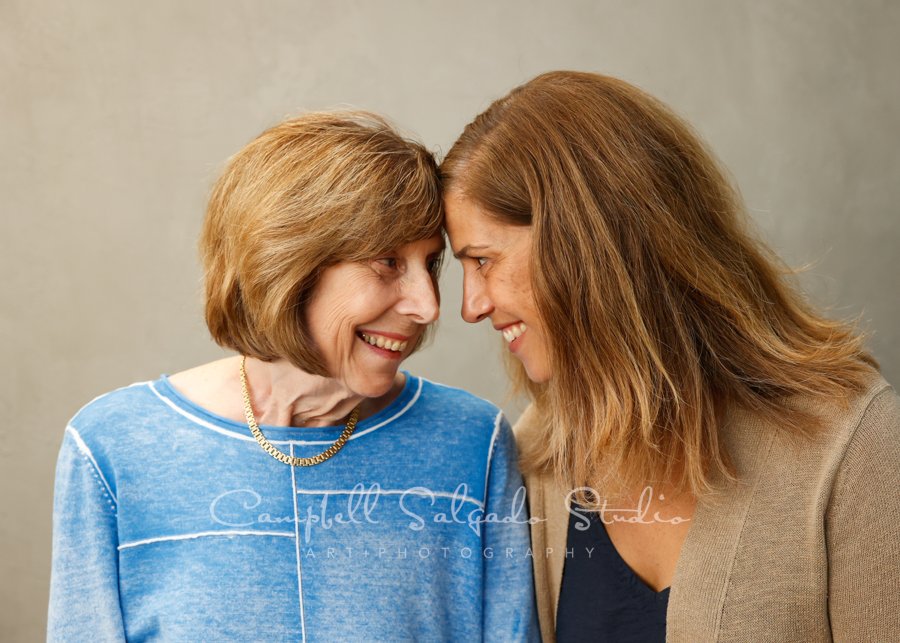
483, 414, 540, 641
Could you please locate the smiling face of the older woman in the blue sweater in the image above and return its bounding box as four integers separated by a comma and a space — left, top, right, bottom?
306, 237, 444, 397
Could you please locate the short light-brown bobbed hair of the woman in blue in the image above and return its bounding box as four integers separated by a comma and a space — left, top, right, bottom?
200, 111, 442, 375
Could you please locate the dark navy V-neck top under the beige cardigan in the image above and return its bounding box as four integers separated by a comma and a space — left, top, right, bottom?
556, 505, 669, 643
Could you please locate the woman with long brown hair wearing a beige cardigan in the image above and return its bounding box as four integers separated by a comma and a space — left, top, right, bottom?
441, 72, 900, 642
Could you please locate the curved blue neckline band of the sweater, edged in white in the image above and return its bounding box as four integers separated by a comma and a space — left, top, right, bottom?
149, 371, 422, 443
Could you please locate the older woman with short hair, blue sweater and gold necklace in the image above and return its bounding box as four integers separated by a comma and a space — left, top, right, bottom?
48, 112, 537, 641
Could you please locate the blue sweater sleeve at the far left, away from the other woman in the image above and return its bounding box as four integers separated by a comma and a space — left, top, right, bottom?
47, 426, 125, 642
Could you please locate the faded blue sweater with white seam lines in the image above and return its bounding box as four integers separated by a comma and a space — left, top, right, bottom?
47, 374, 538, 641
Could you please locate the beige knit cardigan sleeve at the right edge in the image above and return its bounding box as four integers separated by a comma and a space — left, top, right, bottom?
826, 389, 900, 641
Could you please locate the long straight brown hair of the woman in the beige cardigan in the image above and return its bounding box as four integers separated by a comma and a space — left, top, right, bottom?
441, 72, 877, 502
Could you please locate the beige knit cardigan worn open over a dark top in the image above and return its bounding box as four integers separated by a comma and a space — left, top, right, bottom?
515, 377, 900, 643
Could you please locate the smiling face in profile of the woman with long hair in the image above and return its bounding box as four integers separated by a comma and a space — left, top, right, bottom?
444, 192, 550, 382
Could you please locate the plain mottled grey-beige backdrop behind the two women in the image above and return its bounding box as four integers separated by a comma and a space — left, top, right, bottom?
0, 0, 900, 641
